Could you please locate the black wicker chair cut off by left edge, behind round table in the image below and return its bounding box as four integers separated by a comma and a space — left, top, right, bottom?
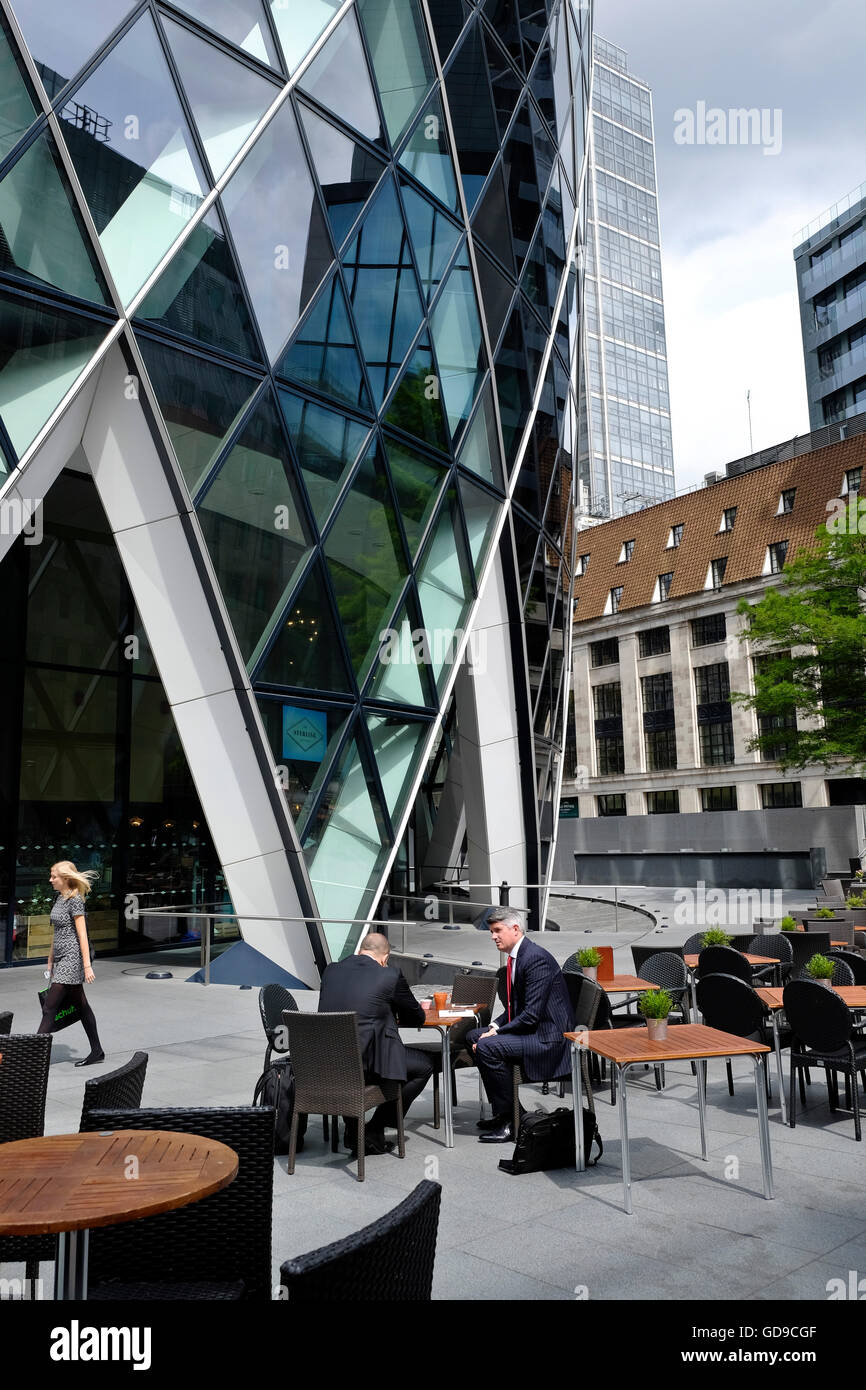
0, 1034, 56, 1282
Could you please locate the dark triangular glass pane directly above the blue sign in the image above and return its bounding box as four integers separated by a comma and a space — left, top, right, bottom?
256, 560, 354, 694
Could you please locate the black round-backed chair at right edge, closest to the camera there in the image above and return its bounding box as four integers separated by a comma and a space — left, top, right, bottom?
783, 980, 866, 1143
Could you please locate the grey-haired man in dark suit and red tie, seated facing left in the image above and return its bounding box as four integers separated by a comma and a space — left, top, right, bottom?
466, 908, 574, 1144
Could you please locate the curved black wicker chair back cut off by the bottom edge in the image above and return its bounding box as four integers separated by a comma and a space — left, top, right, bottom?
279, 1182, 442, 1302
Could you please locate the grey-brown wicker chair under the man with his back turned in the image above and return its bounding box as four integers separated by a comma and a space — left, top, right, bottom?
284, 1012, 406, 1183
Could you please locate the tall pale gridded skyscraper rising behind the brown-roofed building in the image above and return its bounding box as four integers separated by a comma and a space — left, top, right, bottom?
578, 35, 674, 517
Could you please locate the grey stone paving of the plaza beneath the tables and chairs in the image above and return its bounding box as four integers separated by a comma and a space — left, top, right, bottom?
0, 933, 866, 1301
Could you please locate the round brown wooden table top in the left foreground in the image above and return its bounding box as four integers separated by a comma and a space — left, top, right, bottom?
0, 1130, 238, 1236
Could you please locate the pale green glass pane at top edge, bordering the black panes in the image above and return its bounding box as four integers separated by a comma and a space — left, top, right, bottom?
357, 0, 434, 145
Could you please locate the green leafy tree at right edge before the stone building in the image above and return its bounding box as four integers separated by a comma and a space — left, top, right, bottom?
731, 522, 866, 774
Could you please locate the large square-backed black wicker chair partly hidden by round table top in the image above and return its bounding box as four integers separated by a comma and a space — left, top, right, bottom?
83, 1105, 274, 1302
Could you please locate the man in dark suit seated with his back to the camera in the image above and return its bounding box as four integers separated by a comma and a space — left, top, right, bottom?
318, 931, 432, 1154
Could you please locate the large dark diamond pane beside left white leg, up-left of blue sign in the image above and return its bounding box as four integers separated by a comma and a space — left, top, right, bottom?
197, 398, 309, 660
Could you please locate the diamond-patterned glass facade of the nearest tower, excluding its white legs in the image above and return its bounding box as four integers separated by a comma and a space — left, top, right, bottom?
0, 0, 592, 956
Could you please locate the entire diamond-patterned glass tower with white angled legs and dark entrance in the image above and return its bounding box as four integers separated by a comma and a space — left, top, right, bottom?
0, 0, 591, 983
